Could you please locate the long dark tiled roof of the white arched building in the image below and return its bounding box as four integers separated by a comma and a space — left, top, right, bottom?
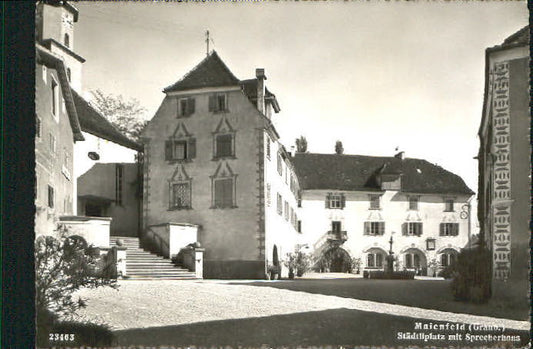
291, 153, 473, 195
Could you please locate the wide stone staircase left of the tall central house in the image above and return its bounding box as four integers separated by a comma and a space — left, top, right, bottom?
110, 236, 196, 280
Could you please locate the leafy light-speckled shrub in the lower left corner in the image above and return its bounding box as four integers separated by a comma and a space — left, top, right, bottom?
35, 225, 118, 341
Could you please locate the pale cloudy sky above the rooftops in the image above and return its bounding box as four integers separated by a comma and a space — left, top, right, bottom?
74, 1, 528, 196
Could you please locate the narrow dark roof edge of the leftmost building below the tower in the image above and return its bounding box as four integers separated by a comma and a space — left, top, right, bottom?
35, 44, 84, 141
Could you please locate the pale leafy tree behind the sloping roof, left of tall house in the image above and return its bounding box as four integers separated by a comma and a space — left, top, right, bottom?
91, 90, 148, 141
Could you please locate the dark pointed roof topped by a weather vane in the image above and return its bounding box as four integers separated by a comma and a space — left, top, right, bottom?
163, 51, 240, 93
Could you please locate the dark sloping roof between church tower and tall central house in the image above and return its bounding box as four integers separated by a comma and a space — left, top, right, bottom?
72, 90, 142, 150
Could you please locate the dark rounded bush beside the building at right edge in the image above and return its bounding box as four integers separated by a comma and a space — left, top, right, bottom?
451, 246, 492, 303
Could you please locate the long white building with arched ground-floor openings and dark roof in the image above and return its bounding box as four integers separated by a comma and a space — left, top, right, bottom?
293, 152, 474, 275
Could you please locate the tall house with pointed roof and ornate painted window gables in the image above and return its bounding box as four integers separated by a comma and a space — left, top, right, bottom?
143, 51, 300, 278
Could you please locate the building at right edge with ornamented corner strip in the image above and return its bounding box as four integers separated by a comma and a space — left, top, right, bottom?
478, 26, 531, 282
